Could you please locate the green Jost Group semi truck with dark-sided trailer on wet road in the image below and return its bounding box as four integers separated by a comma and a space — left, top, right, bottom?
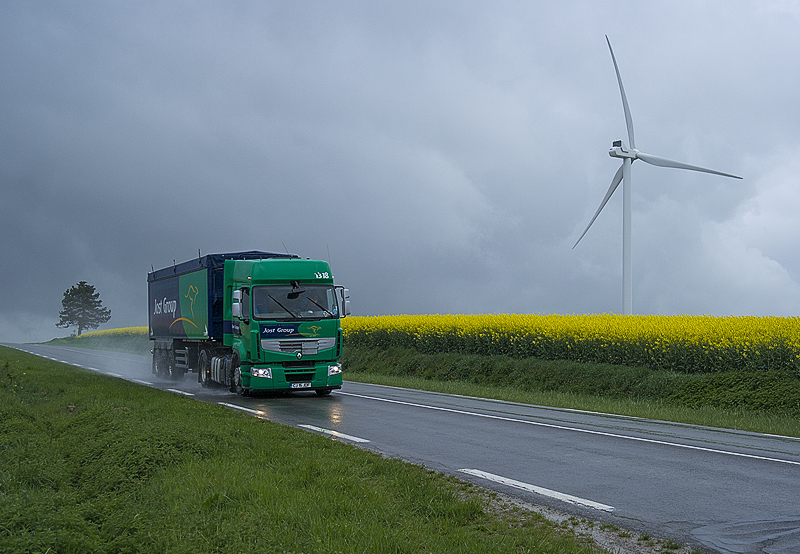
147, 251, 350, 396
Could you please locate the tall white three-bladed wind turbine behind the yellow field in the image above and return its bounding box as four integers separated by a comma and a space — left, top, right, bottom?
572, 35, 741, 315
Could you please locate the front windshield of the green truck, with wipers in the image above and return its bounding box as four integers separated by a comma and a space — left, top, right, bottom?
253, 285, 339, 319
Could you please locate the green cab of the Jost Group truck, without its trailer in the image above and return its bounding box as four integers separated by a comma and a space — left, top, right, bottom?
223, 259, 350, 395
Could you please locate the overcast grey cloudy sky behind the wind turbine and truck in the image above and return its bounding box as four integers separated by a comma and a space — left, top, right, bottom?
0, 0, 800, 341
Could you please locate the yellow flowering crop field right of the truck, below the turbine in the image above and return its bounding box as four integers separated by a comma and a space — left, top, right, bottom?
342, 314, 800, 372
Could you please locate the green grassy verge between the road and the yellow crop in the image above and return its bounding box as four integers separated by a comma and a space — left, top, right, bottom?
342, 347, 800, 437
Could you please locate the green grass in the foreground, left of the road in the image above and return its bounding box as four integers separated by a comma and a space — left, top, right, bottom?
0, 348, 608, 553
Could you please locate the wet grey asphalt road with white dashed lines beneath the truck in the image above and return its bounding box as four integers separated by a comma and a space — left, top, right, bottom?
8, 344, 800, 554
